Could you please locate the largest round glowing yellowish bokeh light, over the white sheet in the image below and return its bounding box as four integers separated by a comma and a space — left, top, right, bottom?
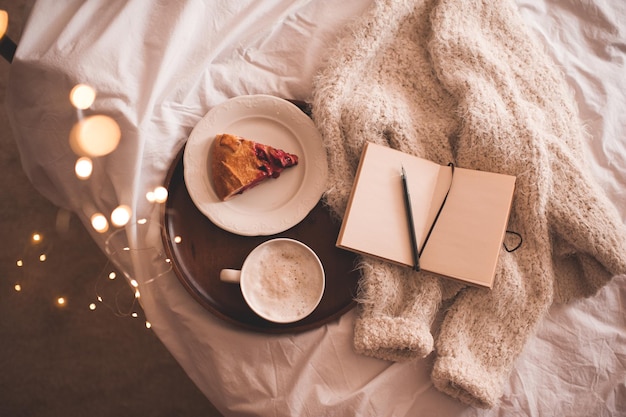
70, 114, 122, 157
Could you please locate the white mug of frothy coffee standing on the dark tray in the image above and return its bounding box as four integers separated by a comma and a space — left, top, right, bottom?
220, 238, 326, 323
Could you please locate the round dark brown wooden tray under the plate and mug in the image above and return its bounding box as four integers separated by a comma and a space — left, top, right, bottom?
161, 149, 359, 333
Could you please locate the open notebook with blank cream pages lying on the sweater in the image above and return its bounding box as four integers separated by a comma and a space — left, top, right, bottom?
337, 143, 515, 288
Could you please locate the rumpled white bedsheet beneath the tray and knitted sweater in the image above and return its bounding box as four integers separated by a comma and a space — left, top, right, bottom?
7, 0, 626, 416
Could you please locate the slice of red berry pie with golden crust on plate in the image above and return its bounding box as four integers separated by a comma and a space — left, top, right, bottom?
210, 133, 298, 201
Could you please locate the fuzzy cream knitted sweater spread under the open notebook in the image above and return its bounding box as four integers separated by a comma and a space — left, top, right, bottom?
313, 0, 626, 407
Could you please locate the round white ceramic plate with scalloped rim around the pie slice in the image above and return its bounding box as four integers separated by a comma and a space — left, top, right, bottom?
183, 95, 328, 236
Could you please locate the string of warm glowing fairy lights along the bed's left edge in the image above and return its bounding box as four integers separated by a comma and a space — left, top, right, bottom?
13, 83, 181, 328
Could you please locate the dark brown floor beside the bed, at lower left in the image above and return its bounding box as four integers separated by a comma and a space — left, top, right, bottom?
0, 0, 220, 417
